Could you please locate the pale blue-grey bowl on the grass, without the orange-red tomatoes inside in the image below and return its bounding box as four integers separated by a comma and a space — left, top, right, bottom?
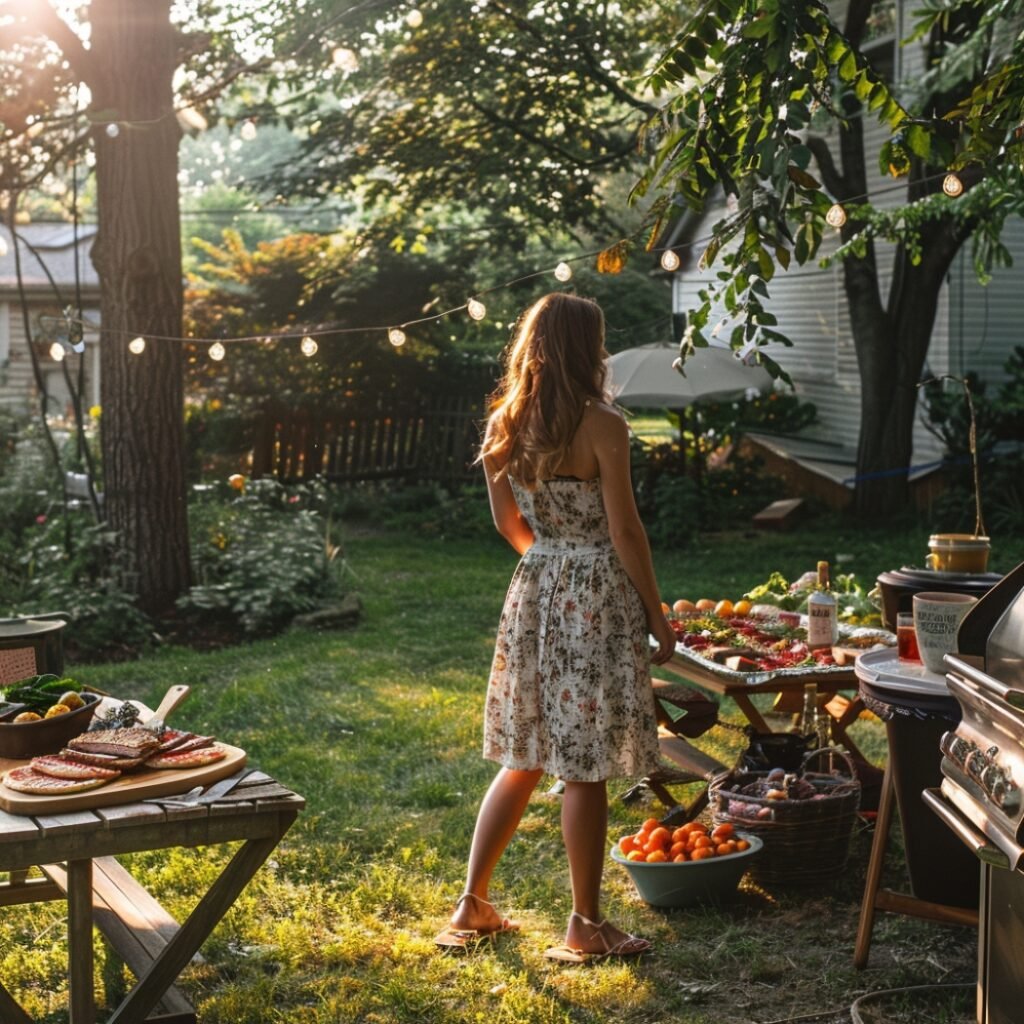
611, 831, 764, 907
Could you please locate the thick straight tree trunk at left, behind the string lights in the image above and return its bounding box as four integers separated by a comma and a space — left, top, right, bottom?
89, 0, 189, 614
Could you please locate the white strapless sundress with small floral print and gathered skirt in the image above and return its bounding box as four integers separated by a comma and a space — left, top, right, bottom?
483, 477, 658, 782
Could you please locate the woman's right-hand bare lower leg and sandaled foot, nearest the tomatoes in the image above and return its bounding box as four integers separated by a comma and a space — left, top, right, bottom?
562, 780, 650, 953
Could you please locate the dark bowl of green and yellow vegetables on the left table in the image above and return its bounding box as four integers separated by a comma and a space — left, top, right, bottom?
0, 675, 100, 761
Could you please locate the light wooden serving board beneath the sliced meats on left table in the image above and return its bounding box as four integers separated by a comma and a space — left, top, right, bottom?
0, 743, 246, 815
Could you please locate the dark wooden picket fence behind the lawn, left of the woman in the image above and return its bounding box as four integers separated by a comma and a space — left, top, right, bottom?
253, 394, 483, 485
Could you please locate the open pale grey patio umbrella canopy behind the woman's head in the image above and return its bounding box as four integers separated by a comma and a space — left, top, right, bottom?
608, 342, 772, 410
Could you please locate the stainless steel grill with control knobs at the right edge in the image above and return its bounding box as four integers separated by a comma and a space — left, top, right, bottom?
924, 565, 1024, 1024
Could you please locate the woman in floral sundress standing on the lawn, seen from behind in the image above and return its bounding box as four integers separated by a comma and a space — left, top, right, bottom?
436, 294, 675, 963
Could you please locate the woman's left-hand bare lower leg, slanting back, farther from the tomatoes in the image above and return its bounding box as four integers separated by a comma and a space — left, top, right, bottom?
452, 768, 544, 929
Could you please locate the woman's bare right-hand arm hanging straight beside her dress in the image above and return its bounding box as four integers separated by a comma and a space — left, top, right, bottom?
587, 407, 676, 665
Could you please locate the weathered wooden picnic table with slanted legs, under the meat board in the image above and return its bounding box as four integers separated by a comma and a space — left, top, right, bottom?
0, 771, 305, 1024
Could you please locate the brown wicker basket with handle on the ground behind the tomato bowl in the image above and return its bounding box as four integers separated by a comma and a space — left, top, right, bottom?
709, 748, 860, 885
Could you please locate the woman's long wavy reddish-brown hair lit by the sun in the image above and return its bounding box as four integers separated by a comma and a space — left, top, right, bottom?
479, 292, 608, 489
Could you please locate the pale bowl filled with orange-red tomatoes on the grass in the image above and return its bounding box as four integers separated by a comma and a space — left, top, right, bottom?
611, 818, 764, 907
